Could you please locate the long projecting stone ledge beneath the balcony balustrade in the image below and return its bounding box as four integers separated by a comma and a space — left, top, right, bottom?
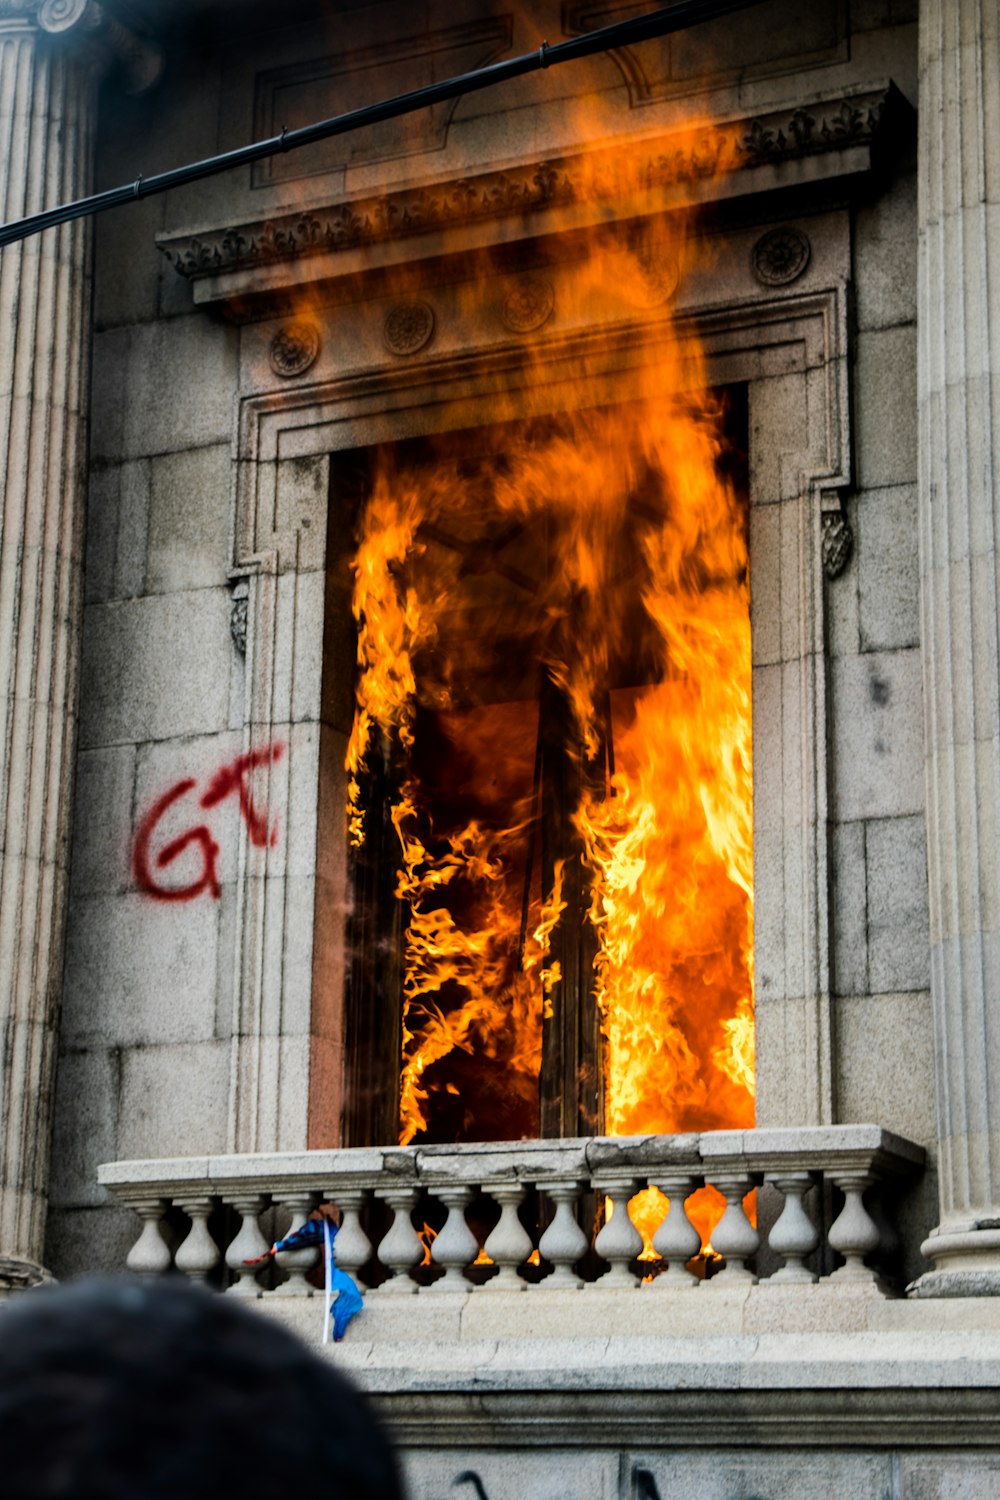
254, 1293, 1000, 1449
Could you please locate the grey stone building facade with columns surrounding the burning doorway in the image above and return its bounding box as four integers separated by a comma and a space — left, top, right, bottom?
0, 0, 1000, 1500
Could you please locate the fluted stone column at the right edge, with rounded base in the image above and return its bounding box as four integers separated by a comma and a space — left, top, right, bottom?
916, 0, 1000, 1296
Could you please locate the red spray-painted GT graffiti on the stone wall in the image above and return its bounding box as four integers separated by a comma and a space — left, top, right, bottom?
132, 744, 285, 902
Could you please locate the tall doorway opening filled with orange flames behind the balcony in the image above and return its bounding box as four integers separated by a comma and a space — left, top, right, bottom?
337, 390, 754, 1145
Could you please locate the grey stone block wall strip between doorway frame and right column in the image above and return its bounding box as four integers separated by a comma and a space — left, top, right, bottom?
829, 141, 934, 1224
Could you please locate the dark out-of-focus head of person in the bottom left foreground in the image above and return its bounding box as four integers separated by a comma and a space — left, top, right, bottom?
0, 1278, 403, 1500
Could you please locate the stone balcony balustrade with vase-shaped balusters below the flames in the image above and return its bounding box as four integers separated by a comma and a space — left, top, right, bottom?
99, 1125, 924, 1299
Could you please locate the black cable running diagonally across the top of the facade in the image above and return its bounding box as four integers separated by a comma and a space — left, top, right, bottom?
0, 0, 760, 246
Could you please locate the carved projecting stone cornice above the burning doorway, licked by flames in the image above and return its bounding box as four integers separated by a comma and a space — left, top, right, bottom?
157, 84, 912, 295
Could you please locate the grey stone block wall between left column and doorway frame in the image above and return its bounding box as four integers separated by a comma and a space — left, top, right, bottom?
46, 35, 241, 1275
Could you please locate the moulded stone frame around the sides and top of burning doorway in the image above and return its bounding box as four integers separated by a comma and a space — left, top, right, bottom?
229, 212, 850, 1151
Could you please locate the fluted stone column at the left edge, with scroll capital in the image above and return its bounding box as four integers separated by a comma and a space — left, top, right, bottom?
0, 0, 106, 1289
